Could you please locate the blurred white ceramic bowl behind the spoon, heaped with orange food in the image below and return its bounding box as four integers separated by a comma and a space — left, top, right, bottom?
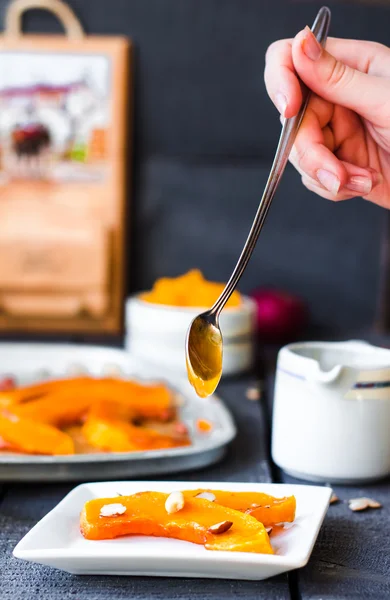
125, 296, 256, 376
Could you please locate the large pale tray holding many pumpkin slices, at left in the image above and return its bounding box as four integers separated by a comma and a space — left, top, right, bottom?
0, 343, 236, 481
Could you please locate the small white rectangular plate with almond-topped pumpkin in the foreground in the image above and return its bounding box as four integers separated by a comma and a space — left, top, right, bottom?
14, 481, 331, 580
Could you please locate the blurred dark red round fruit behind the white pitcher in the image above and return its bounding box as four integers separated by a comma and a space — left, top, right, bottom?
252, 289, 308, 342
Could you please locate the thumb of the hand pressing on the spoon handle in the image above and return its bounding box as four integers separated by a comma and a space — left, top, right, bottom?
292, 27, 390, 124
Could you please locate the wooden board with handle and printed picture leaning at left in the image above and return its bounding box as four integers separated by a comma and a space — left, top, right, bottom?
0, 0, 131, 334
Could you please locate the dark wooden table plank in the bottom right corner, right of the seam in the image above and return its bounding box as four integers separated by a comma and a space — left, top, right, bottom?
282, 475, 390, 600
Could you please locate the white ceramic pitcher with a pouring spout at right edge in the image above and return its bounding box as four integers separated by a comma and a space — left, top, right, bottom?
272, 341, 390, 483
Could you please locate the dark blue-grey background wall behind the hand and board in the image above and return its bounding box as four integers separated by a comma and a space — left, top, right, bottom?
0, 0, 390, 332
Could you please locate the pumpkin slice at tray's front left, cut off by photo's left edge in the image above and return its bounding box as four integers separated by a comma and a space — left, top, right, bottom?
0, 412, 74, 454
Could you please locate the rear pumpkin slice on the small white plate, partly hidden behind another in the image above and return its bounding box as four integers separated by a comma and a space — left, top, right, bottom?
183, 489, 296, 527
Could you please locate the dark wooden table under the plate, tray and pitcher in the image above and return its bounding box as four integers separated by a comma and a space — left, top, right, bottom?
0, 379, 390, 600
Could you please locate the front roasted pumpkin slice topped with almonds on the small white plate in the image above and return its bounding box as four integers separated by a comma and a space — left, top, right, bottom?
80, 492, 273, 554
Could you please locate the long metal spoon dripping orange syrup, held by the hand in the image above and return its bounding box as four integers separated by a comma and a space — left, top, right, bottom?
186, 7, 331, 397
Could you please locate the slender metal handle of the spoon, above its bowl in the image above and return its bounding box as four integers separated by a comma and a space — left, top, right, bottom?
210, 6, 331, 315
